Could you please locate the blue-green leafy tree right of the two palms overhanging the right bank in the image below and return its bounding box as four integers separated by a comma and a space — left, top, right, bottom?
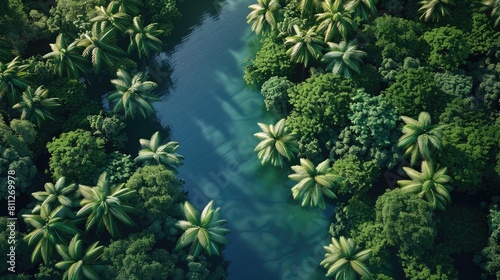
330, 90, 400, 168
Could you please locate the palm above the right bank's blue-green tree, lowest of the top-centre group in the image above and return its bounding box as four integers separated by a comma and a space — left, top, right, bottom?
323, 41, 366, 79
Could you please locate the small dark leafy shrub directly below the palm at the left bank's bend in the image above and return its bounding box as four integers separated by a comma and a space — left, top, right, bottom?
87, 112, 128, 148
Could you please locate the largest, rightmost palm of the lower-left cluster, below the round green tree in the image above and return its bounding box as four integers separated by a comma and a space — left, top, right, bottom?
76, 172, 135, 237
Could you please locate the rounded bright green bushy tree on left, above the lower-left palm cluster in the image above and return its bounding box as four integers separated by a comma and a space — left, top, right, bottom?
47, 129, 106, 184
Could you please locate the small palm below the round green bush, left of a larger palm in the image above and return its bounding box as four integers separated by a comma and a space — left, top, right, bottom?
31, 177, 77, 217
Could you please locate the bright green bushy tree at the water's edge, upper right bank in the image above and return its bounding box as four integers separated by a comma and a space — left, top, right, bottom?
243, 37, 294, 85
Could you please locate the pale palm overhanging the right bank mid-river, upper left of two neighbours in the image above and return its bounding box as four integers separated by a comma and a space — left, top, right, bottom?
254, 119, 299, 167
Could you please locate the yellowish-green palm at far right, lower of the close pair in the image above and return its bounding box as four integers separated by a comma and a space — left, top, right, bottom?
398, 160, 452, 210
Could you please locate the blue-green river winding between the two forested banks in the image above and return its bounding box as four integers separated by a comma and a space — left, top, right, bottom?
155, 0, 329, 280
